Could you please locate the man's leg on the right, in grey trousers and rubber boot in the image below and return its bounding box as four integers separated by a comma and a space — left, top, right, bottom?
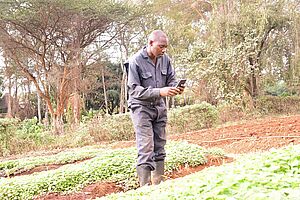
152, 107, 167, 185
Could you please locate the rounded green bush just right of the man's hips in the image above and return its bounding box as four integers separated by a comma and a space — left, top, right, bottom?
168, 102, 218, 133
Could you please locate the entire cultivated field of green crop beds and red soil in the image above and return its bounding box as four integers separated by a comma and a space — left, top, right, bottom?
0, 115, 300, 200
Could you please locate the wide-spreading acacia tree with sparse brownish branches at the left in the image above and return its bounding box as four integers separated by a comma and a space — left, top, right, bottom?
0, 0, 134, 133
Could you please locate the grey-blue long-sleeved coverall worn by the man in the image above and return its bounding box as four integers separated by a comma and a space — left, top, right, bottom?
127, 47, 176, 171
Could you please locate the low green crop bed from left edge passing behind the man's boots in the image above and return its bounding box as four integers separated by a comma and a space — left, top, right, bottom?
0, 143, 220, 200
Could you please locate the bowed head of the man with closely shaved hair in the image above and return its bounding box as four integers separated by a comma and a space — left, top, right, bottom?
147, 30, 169, 58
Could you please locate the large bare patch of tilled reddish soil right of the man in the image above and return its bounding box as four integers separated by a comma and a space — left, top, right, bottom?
169, 115, 300, 154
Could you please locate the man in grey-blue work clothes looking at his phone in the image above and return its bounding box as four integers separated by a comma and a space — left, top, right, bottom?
125, 30, 184, 186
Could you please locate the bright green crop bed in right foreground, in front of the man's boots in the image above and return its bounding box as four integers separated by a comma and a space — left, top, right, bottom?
102, 145, 300, 200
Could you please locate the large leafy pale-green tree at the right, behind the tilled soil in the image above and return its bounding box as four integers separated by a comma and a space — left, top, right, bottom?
182, 0, 299, 104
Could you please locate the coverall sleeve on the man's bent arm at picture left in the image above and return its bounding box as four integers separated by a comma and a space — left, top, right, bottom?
127, 61, 160, 100
